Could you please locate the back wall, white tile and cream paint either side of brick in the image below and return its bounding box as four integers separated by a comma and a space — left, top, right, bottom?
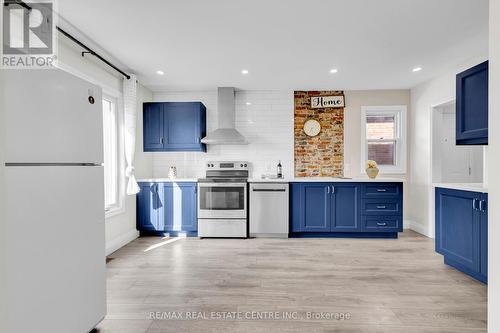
149, 89, 411, 217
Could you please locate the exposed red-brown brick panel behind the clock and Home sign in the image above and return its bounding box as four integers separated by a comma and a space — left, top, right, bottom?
294, 91, 344, 177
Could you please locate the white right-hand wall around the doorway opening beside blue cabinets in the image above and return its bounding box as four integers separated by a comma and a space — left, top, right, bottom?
407, 56, 486, 237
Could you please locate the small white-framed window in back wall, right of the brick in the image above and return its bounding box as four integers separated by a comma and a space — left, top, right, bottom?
361, 105, 406, 173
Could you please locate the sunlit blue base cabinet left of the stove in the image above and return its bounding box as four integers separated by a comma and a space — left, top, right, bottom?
137, 182, 198, 236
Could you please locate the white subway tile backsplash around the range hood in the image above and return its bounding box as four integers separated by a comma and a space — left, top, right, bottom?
153, 89, 293, 178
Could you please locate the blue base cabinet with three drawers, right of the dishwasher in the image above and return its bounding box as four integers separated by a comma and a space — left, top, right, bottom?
290, 182, 403, 238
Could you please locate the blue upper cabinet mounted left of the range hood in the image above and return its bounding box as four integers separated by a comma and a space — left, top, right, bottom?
143, 102, 207, 152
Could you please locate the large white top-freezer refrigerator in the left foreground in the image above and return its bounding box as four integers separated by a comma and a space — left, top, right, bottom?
1, 70, 106, 333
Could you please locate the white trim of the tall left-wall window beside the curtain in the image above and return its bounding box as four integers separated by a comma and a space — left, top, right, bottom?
101, 88, 125, 219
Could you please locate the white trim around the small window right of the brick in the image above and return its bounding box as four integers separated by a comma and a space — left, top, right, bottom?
360, 105, 408, 174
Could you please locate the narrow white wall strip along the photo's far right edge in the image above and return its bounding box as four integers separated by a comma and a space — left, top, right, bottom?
487, 0, 500, 333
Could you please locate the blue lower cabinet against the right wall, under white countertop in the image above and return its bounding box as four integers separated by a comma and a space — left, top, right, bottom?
435, 188, 488, 283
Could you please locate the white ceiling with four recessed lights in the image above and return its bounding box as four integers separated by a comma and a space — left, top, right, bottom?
59, 0, 488, 90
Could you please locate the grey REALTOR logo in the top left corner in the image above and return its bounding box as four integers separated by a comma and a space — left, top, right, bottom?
1, 0, 56, 69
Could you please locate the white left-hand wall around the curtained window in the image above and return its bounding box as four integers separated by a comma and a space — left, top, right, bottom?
58, 37, 153, 254
